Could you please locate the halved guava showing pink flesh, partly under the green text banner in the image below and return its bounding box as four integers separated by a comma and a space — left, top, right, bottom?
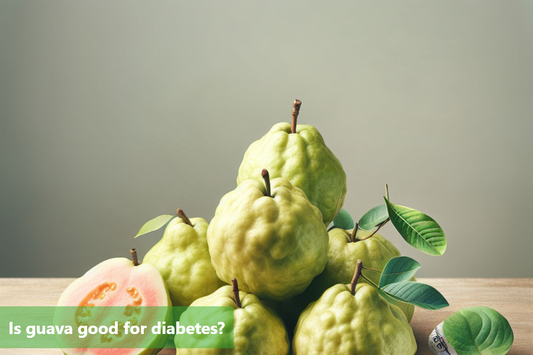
54, 253, 172, 355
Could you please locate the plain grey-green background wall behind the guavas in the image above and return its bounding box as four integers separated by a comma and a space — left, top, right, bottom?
0, 0, 533, 277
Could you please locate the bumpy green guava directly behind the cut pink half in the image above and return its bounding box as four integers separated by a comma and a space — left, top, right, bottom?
143, 217, 225, 306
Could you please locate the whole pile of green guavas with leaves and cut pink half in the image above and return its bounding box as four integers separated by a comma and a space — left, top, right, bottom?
59, 100, 454, 355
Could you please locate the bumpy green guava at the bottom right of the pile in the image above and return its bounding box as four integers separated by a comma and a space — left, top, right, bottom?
293, 283, 417, 355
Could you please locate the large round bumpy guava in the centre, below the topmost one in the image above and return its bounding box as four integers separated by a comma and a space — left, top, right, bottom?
207, 178, 328, 301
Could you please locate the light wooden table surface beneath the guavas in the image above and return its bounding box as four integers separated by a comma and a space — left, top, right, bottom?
0, 278, 533, 355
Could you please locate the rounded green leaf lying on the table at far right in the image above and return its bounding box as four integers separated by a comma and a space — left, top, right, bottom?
443, 307, 514, 355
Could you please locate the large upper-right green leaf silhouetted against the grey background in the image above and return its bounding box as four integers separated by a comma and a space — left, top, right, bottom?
384, 197, 447, 255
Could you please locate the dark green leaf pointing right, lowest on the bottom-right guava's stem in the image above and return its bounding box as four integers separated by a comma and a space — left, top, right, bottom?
381, 281, 449, 310
